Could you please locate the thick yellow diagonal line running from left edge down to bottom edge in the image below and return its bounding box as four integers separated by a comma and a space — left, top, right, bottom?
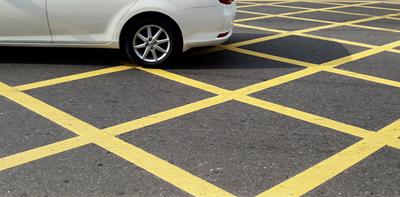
0, 83, 233, 197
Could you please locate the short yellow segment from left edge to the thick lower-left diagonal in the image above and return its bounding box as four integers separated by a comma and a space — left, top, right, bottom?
0, 137, 90, 171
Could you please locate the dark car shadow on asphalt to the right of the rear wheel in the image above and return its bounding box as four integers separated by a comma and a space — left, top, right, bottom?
170, 34, 365, 69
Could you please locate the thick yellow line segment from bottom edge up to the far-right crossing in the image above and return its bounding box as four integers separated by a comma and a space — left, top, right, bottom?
257, 140, 385, 197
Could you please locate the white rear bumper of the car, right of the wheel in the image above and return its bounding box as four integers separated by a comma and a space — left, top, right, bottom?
177, 3, 236, 51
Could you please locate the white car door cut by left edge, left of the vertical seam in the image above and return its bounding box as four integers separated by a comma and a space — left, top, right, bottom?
0, 0, 51, 43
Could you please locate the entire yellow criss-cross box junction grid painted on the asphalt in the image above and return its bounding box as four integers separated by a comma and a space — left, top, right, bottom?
0, 0, 400, 196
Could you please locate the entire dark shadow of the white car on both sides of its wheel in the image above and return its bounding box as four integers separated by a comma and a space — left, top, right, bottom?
0, 33, 362, 70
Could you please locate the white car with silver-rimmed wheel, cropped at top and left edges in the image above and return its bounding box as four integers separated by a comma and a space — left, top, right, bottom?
0, 0, 236, 66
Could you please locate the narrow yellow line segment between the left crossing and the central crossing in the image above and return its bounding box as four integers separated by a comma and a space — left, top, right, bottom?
103, 96, 231, 135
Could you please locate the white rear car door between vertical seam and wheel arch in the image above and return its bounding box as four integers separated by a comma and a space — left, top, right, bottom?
47, 0, 136, 44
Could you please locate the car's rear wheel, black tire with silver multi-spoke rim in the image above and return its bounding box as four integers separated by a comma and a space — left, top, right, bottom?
124, 17, 182, 67
